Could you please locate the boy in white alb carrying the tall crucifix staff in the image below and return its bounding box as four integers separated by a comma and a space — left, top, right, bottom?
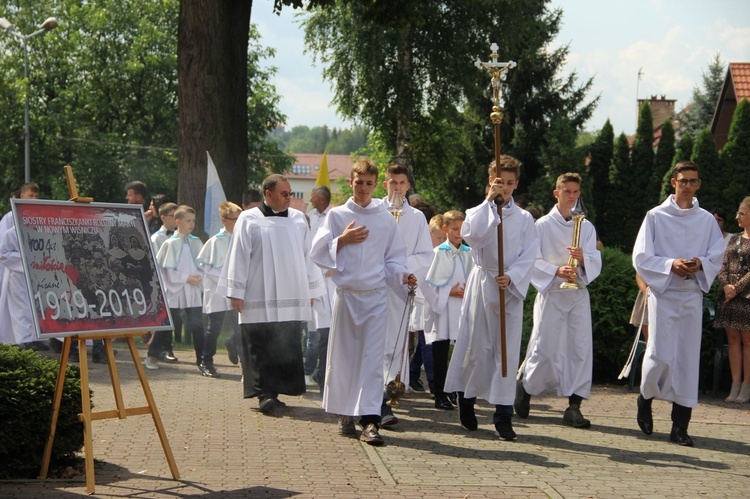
445, 156, 538, 440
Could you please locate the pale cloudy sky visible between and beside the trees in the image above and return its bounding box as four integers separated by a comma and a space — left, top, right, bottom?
251, 0, 750, 134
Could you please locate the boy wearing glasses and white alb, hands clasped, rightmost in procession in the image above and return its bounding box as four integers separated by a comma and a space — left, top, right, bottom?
633, 161, 724, 447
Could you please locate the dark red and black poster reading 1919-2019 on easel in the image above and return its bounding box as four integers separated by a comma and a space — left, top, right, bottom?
11, 199, 172, 339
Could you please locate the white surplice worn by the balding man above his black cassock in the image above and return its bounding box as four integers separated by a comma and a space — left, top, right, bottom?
216, 207, 325, 324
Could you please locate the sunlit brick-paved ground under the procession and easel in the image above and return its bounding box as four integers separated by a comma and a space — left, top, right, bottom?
0, 351, 750, 498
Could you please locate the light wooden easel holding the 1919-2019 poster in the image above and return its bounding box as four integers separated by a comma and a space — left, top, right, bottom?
39, 166, 180, 494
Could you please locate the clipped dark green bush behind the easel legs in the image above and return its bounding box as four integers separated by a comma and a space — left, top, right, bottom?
0, 345, 83, 479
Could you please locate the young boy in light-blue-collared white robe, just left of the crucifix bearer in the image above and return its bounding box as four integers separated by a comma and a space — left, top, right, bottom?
423, 210, 474, 410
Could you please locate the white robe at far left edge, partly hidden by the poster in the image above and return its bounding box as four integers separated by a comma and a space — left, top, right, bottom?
0, 224, 37, 345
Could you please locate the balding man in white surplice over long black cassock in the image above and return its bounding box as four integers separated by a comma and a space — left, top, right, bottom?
216, 174, 325, 414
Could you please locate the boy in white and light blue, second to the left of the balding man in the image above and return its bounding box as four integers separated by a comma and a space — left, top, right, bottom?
154, 205, 204, 373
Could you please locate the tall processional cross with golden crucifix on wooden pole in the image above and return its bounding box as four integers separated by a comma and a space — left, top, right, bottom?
474, 43, 516, 378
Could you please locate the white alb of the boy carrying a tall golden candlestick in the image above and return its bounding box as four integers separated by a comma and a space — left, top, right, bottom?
523, 205, 604, 399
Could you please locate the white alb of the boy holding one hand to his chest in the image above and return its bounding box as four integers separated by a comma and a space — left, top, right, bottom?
310, 198, 409, 416
